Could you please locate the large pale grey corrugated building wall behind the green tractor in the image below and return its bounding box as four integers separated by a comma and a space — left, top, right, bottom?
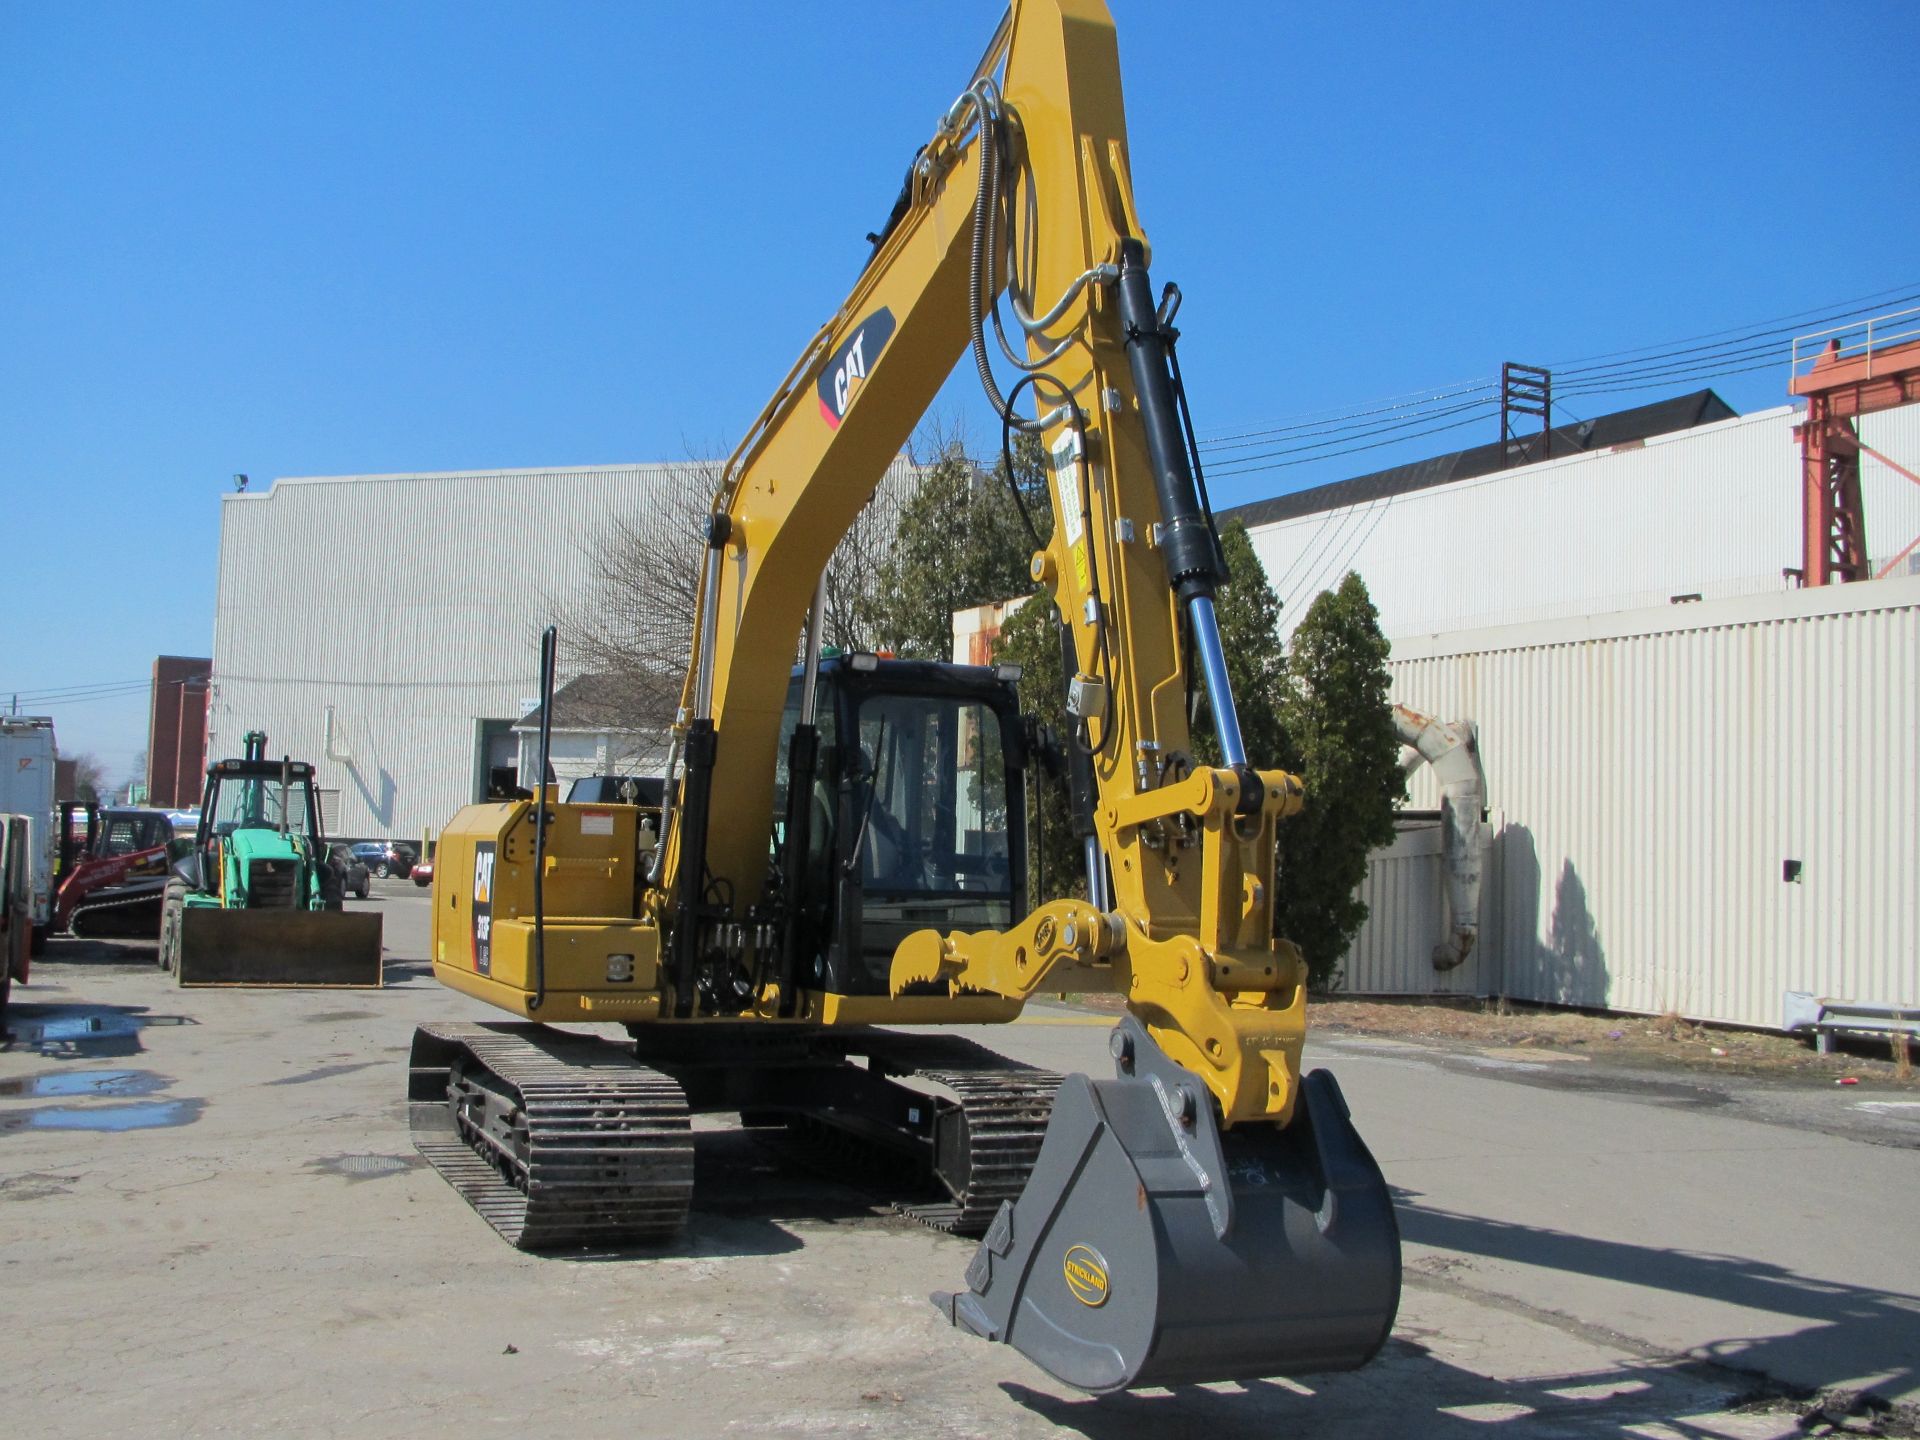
207, 459, 914, 837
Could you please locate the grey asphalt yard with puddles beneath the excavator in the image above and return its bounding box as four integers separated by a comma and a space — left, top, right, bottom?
0, 881, 1920, 1440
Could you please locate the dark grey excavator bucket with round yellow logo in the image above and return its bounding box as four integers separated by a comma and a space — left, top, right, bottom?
933, 1016, 1400, 1394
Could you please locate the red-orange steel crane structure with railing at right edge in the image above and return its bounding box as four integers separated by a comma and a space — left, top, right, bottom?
1789, 309, 1920, 586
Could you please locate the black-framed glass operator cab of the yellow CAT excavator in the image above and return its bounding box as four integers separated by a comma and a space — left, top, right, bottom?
774, 655, 1027, 995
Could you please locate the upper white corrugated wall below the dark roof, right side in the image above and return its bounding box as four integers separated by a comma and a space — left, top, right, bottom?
1250, 405, 1920, 637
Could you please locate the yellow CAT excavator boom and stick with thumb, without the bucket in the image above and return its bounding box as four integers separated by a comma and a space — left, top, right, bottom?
657, 0, 1306, 1125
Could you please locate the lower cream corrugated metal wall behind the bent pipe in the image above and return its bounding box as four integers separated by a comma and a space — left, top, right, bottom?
1348, 578, 1920, 1025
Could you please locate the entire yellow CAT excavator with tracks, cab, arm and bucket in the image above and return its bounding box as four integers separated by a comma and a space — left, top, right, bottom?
409, 0, 1400, 1392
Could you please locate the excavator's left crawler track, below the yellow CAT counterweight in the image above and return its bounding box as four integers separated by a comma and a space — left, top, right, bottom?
409, 1023, 693, 1250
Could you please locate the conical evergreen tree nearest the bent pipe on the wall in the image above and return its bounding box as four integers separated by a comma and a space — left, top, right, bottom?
1273, 572, 1404, 985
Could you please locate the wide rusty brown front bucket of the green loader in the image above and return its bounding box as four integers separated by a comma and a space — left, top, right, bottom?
177, 906, 380, 989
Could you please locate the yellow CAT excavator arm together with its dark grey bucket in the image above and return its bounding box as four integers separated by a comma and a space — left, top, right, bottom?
647, 0, 1400, 1390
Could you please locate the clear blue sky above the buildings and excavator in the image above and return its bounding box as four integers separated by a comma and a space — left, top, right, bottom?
0, 0, 1920, 772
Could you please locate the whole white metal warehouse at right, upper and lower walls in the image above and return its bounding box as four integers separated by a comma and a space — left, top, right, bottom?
1227, 392, 1920, 1025
